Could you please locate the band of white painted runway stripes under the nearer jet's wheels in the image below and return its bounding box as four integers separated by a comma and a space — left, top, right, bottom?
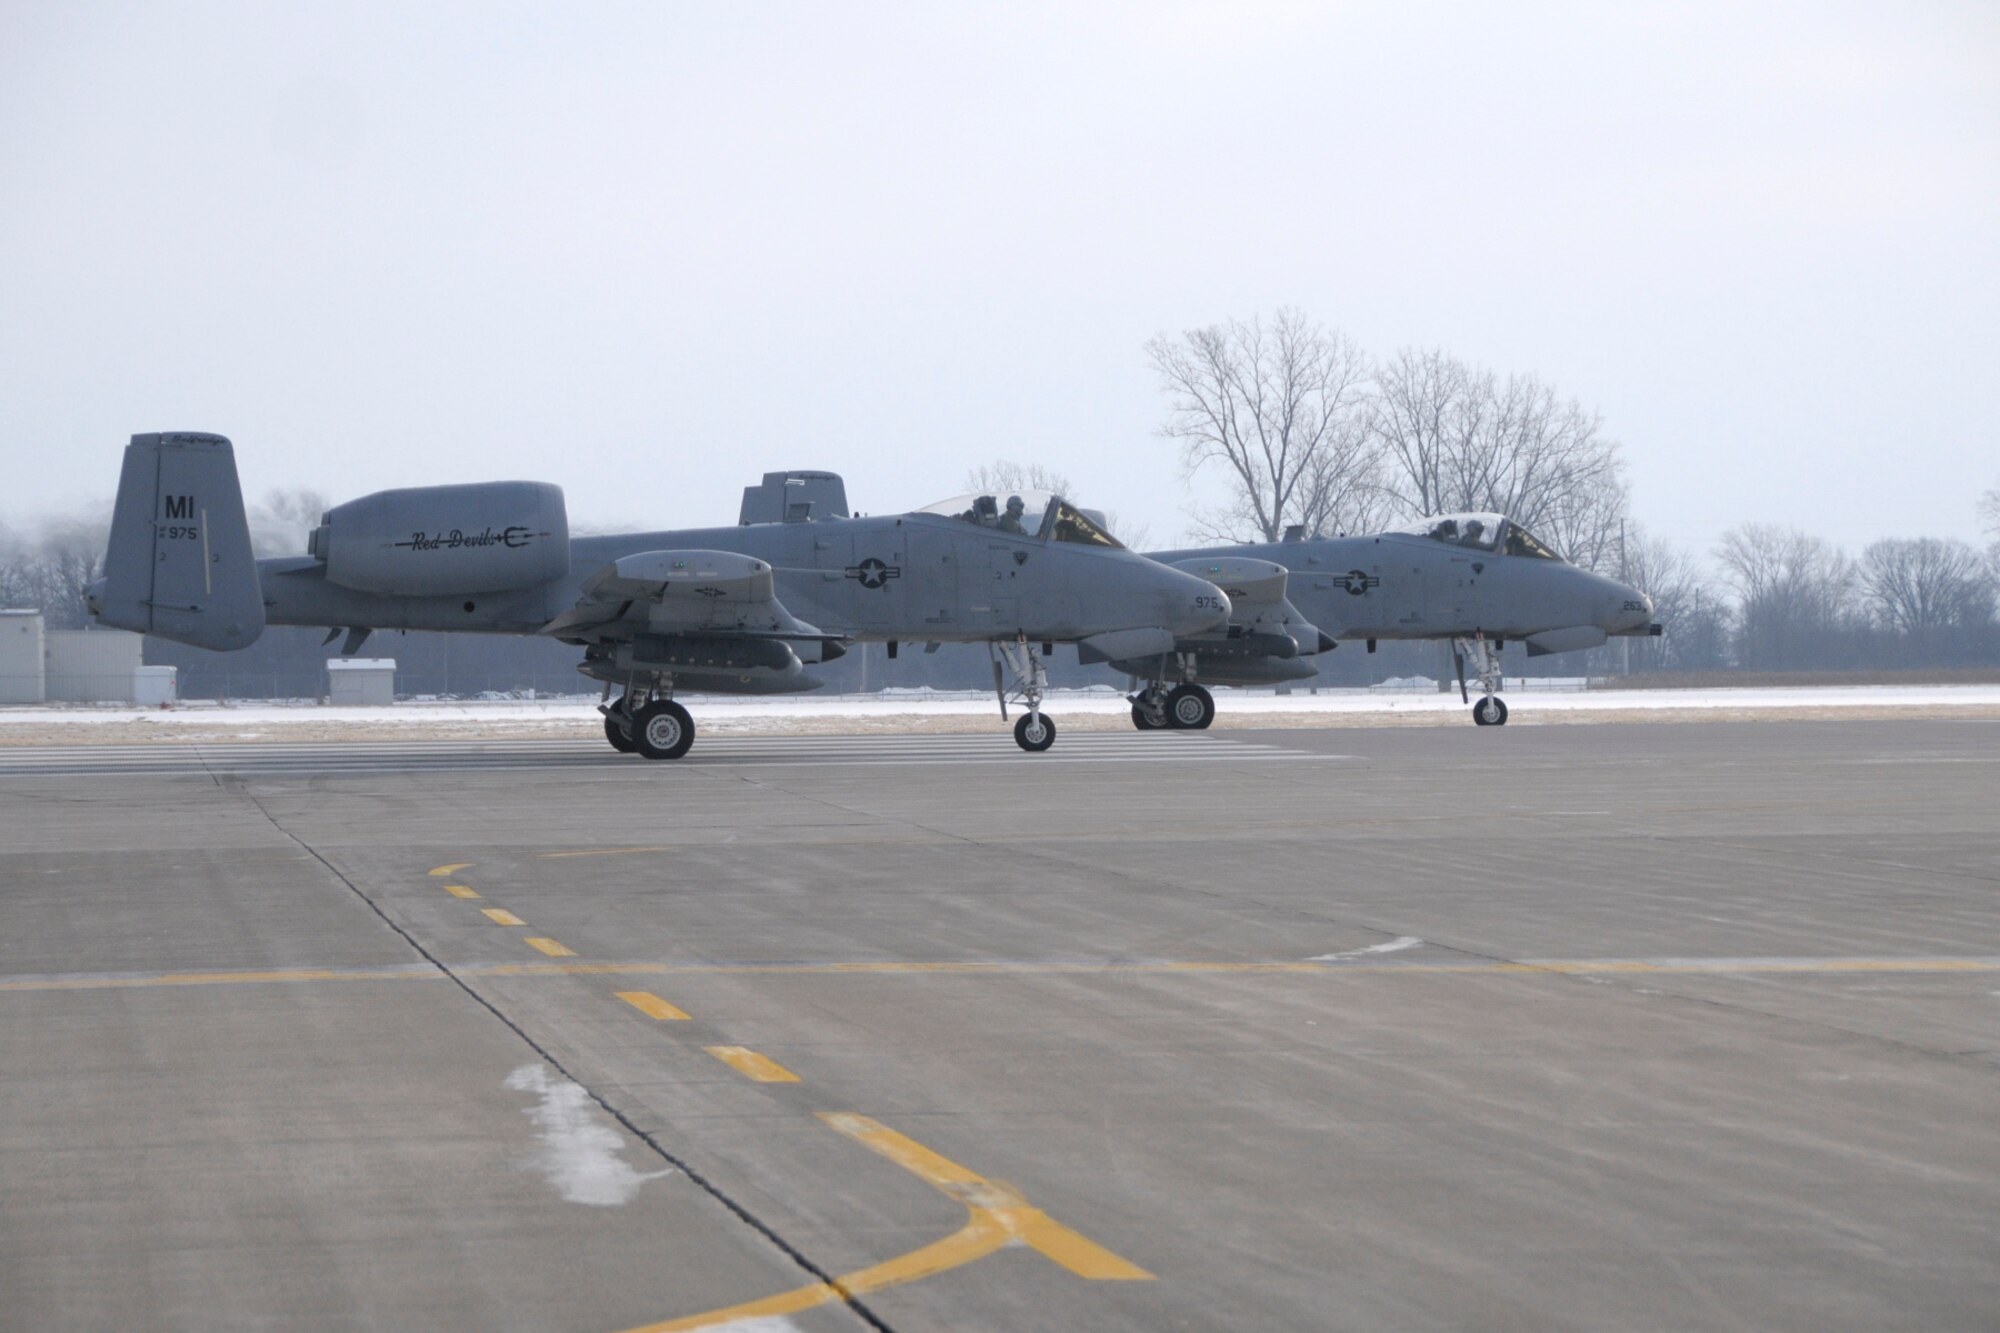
0, 733, 1352, 779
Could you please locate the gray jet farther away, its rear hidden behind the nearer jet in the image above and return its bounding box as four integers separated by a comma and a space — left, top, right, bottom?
1104, 514, 1660, 731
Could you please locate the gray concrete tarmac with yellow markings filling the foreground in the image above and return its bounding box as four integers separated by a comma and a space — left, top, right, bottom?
0, 721, 2000, 1331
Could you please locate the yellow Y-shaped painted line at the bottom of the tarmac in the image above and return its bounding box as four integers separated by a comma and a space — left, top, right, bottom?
628, 1111, 1152, 1333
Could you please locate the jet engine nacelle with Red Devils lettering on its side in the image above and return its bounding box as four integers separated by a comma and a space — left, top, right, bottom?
308, 482, 570, 596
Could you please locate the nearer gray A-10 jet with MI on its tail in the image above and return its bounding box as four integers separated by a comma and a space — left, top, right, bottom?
84, 432, 1230, 759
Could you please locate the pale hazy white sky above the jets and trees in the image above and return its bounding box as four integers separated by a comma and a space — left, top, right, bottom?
0, 0, 2000, 550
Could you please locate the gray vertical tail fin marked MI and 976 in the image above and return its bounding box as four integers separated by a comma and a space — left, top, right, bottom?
88, 432, 264, 648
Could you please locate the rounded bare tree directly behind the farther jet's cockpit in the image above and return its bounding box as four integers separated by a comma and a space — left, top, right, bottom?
1368, 348, 1626, 566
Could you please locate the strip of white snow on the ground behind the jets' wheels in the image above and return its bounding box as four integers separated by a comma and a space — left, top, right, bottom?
0, 681, 2000, 745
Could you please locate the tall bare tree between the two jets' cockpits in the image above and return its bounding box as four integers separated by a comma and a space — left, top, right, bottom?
1146, 308, 1374, 542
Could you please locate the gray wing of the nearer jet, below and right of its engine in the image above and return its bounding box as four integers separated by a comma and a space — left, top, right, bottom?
542, 550, 832, 642
